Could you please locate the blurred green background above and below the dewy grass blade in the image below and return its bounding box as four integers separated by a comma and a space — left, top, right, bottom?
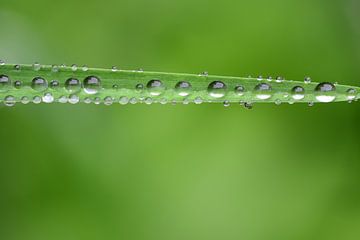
0, 0, 360, 240
